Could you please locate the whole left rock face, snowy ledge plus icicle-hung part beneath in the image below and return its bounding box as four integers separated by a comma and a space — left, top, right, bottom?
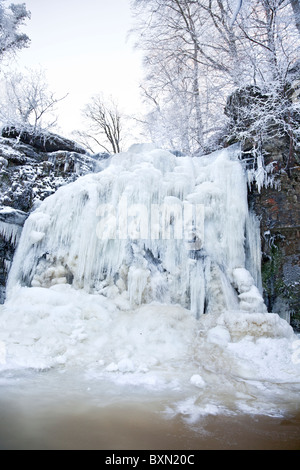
0, 129, 107, 303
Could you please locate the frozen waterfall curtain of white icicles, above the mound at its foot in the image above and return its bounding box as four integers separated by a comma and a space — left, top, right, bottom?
8, 144, 266, 318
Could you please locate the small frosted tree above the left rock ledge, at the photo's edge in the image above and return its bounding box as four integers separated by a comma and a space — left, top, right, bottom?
0, 69, 65, 134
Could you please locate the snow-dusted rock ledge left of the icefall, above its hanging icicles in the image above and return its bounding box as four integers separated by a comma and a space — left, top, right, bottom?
0, 133, 100, 212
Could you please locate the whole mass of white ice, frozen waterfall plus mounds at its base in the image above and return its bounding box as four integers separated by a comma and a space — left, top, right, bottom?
0, 146, 300, 419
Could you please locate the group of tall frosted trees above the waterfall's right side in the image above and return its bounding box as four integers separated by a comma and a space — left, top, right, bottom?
134, 0, 299, 153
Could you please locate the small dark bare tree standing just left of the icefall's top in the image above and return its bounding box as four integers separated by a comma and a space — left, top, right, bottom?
76, 94, 123, 153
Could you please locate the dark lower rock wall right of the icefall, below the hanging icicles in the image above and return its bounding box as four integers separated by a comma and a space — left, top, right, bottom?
249, 167, 300, 330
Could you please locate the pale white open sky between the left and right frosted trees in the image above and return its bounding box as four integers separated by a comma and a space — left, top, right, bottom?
15, 0, 142, 146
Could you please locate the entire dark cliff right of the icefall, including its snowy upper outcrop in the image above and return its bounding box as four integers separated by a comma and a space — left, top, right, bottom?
225, 81, 300, 331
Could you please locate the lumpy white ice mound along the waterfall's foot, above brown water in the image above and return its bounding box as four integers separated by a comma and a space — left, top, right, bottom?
0, 284, 300, 419
